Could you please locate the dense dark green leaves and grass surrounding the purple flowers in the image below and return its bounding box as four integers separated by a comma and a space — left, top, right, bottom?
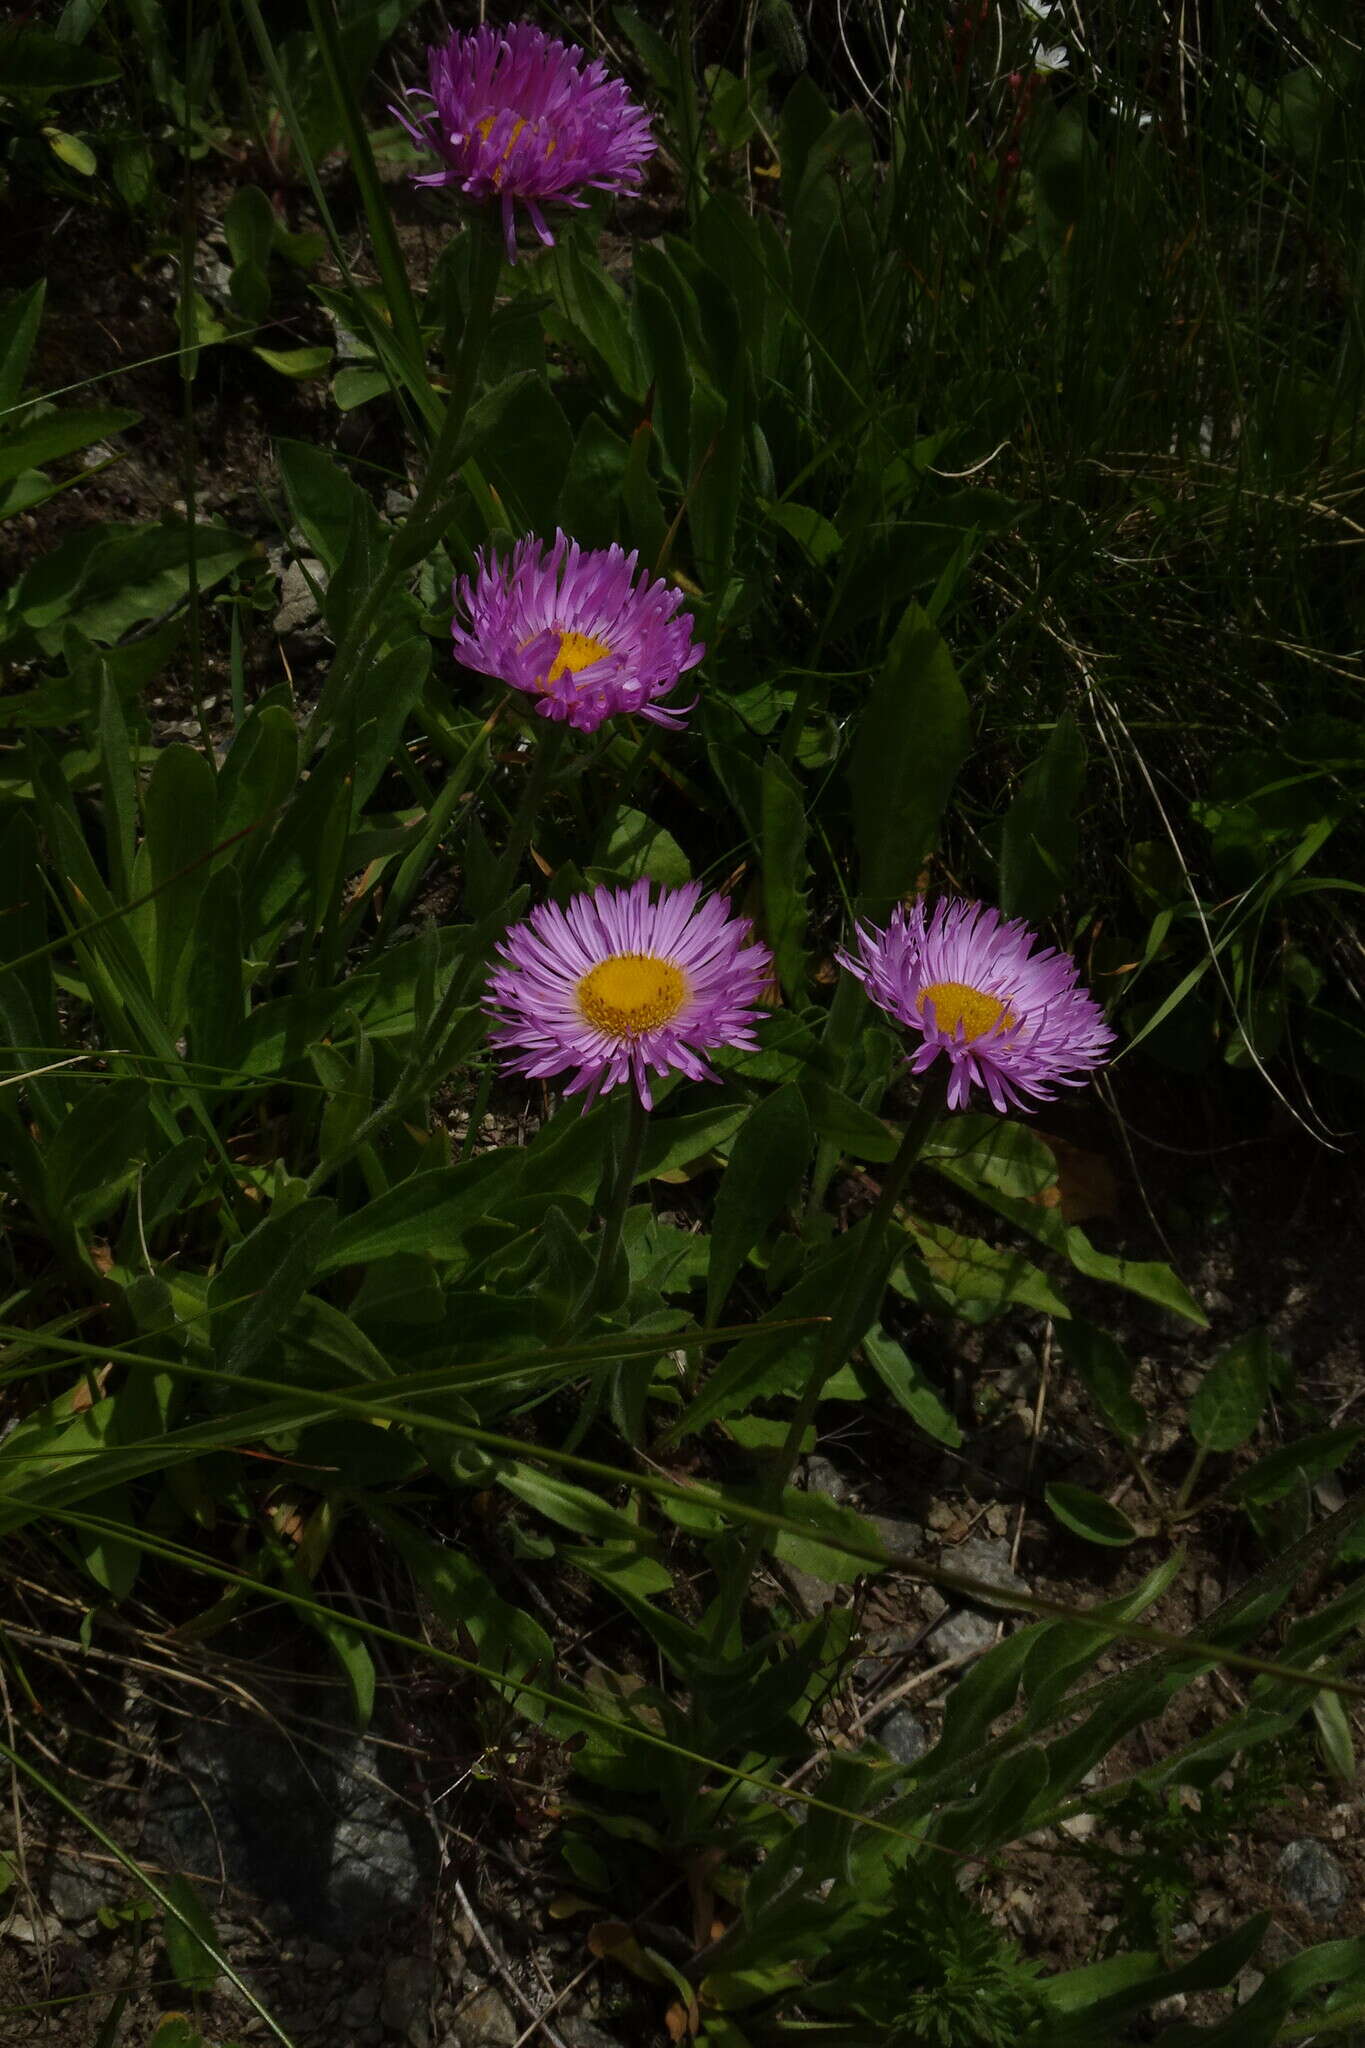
0, 0, 1365, 2048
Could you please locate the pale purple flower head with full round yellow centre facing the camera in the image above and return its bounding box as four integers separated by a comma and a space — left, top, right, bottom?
483, 881, 772, 1110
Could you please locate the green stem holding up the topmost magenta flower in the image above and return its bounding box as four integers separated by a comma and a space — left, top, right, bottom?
305, 217, 501, 745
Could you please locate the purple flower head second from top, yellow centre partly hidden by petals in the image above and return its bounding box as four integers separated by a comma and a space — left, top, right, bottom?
450, 532, 706, 733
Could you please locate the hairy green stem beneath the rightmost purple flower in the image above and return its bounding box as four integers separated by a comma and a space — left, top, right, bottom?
712, 1063, 948, 1651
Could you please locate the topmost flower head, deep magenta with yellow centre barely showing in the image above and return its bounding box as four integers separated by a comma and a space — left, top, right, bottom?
393, 20, 655, 262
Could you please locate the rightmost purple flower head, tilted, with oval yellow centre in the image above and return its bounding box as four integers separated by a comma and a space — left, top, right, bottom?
839, 901, 1113, 1114
